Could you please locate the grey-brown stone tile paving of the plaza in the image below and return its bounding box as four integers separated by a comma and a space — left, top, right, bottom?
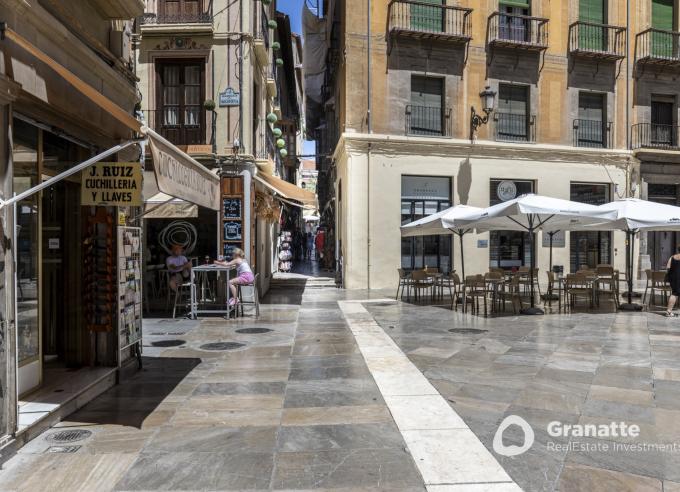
0, 275, 680, 492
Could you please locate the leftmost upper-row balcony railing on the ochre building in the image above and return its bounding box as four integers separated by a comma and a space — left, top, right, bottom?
388, 0, 472, 42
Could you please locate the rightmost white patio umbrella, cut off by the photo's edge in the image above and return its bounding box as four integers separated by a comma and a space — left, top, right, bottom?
587, 198, 680, 311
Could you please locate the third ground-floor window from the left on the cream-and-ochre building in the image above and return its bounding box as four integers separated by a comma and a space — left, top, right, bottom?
569, 183, 612, 272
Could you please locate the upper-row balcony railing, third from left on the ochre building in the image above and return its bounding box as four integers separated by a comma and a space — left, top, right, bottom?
569, 21, 626, 60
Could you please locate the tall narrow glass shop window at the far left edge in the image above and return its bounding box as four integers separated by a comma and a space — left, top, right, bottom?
12, 119, 40, 367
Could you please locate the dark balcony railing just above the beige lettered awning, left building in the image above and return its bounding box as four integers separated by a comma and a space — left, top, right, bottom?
144, 111, 212, 145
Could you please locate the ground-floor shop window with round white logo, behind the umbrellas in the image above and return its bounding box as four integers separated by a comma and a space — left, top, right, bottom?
489, 179, 534, 270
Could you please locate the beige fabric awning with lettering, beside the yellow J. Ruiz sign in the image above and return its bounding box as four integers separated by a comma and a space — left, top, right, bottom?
141, 127, 220, 210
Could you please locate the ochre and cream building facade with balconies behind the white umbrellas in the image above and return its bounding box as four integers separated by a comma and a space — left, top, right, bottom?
310, 0, 680, 288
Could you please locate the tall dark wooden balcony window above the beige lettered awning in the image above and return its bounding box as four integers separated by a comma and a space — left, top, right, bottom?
155, 60, 208, 145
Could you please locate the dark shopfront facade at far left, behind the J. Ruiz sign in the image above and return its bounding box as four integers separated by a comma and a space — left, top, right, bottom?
0, 0, 143, 455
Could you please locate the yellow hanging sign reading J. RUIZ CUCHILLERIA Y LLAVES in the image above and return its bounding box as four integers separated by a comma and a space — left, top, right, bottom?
80, 162, 142, 207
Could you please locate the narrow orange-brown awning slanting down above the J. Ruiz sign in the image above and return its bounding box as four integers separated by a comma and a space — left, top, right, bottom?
0, 23, 141, 132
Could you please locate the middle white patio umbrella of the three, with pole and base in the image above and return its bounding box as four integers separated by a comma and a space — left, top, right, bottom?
459, 194, 616, 314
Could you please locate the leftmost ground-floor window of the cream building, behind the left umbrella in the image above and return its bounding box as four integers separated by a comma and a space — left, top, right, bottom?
401, 176, 452, 272
